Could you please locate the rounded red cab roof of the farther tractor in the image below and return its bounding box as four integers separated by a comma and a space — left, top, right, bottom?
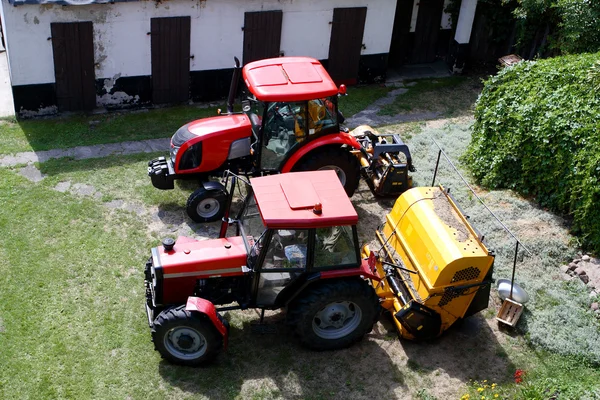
242, 57, 338, 101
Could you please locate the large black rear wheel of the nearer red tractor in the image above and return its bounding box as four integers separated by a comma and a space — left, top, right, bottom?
287, 280, 381, 350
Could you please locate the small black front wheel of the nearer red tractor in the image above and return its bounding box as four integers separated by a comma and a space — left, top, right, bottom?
152, 305, 223, 367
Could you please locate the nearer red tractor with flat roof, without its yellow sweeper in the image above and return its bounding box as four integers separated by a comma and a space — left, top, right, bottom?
145, 171, 380, 366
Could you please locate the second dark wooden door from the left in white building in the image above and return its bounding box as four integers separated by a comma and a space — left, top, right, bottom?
150, 17, 190, 104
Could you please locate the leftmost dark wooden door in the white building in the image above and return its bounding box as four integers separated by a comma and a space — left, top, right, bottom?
50, 22, 96, 111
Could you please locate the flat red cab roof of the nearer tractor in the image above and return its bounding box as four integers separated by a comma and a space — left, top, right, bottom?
250, 171, 358, 228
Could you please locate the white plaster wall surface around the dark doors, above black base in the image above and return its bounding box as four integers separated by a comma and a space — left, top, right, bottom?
0, 0, 396, 85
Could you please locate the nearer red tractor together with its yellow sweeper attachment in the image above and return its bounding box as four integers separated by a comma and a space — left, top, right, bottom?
145, 171, 493, 366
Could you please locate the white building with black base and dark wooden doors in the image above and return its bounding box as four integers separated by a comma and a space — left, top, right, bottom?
0, 0, 476, 112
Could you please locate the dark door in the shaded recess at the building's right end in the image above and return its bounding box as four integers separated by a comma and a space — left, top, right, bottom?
410, 0, 444, 64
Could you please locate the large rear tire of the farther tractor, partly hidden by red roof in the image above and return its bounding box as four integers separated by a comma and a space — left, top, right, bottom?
294, 147, 360, 197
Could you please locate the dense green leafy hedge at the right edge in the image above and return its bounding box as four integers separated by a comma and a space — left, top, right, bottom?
465, 53, 600, 252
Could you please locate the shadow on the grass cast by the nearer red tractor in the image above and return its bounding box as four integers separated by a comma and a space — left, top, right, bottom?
158, 310, 406, 399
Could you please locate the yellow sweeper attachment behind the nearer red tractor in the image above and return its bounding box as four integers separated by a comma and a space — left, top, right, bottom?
363, 186, 494, 339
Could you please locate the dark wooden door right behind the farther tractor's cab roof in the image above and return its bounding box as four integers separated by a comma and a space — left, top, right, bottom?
244, 10, 283, 65
